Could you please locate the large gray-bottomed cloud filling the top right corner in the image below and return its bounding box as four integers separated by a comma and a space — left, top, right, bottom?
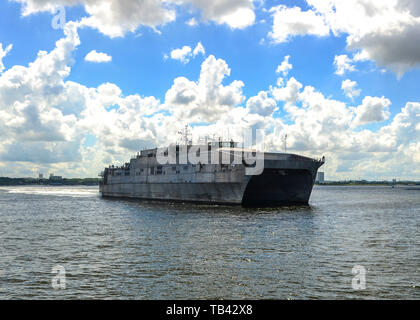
308, 0, 420, 75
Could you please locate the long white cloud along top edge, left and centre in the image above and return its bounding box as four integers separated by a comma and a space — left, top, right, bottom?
13, 0, 255, 38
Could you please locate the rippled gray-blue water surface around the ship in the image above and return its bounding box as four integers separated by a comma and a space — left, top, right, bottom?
0, 186, 420, 299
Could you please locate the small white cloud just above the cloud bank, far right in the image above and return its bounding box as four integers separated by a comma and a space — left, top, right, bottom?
353, 96, 391, 125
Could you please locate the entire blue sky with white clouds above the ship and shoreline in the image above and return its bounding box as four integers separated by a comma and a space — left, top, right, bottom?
0, 0, 420, 179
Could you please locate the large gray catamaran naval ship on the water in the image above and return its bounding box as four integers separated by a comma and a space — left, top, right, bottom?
99, 136, 325, 206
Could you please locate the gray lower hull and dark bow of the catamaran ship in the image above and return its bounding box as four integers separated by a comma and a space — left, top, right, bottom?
100, 154, 322, 206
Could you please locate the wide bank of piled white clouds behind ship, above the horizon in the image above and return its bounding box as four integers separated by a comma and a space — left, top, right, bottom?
0, 23, 420, 179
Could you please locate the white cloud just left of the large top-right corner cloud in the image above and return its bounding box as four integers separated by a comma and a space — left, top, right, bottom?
268, 5, 330, 43
